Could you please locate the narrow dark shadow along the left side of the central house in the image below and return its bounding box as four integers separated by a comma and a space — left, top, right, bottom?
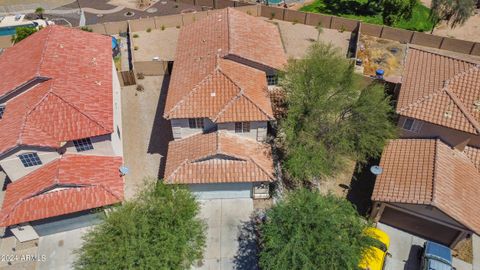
147, 75, 173, 179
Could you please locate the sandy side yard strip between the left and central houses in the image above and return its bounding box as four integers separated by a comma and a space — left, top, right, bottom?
122, 76, 172, 199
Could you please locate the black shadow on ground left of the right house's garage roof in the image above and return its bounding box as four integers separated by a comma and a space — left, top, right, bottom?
347, 159, 379, 217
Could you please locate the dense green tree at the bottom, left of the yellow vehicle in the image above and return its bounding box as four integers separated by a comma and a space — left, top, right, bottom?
259, 189, 375, 270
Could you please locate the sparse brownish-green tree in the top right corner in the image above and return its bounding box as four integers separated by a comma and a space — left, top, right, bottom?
430, 0, 475, 32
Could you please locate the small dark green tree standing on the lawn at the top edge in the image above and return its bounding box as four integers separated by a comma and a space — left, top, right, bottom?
382, 0, 417, 25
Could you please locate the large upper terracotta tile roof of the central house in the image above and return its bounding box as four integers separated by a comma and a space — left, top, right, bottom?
164, 8, 286, 122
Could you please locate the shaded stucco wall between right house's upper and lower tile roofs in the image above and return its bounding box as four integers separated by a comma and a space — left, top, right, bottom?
398, 116, 480, 147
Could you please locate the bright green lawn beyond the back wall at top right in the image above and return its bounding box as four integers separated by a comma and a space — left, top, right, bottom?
300, 0, 433, 32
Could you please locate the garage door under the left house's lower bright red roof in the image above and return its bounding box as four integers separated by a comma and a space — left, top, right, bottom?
31, 211, 103, 236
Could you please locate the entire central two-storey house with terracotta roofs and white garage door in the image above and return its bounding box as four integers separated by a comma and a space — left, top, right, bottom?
164, 8, 287, 198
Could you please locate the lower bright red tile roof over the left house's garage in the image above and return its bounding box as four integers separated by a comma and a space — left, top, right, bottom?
0, 155, 124, 226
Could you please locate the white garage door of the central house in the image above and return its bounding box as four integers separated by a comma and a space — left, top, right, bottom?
189, 183, 252, 200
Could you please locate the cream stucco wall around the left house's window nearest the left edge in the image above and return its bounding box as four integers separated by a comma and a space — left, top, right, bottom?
0, 146, 60, 181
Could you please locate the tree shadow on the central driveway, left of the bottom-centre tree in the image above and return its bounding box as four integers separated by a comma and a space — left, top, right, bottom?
233, 214, 260, 270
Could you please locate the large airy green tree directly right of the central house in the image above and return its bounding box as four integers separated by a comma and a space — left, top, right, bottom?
280, 43, 396, 184
